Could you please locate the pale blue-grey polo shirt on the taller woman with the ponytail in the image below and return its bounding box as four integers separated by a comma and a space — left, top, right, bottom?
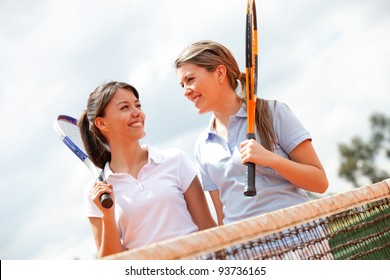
195, 101, 311, 224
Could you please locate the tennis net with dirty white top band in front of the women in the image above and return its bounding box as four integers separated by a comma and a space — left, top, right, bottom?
107, 179, 390, 260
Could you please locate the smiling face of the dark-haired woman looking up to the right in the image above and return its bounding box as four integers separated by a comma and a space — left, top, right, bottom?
95, 88, 145, 143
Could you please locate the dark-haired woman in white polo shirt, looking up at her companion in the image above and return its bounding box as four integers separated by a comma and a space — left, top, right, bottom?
79, 81, 216, 257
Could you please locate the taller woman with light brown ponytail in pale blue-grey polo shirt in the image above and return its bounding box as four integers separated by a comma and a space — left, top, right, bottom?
175, 40, 328, 224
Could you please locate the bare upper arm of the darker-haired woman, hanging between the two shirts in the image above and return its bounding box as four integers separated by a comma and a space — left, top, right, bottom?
184, 176, 216, 230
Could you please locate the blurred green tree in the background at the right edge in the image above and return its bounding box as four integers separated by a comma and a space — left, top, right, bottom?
339, 113, 390, 187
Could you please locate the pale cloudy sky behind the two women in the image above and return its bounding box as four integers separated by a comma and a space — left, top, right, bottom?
0, 0, 390, 260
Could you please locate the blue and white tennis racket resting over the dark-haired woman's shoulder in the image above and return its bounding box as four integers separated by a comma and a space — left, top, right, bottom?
53, 115, 113, 208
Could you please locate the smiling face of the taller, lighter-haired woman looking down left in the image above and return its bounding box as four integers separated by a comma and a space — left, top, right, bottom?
177, 63, 220, 114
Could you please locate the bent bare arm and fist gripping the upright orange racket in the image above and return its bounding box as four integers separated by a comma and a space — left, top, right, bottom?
241, 140, 328, 193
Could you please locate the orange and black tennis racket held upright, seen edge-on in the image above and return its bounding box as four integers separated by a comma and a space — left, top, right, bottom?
244, 0, 257, 196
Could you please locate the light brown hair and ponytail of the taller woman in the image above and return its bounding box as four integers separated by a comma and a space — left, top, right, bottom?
175, 40, 276, 151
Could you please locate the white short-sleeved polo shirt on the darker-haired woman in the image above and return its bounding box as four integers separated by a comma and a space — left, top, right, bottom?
85, 145, 198, 249
